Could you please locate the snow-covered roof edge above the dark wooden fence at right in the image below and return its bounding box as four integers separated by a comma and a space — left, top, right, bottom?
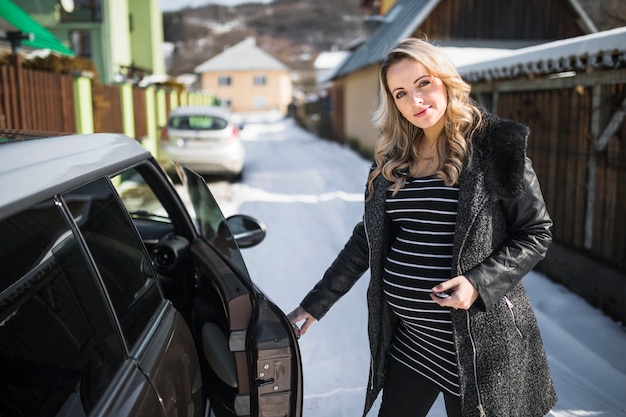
458, 27, 626, 82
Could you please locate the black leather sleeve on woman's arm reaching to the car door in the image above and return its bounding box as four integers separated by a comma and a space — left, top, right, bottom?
300, 222, 369, 320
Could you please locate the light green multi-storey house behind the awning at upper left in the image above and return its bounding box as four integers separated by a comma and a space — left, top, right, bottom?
11, 0, 165, 84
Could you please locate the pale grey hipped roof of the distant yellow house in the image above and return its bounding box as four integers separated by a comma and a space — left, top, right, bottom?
194, 37, 288, 73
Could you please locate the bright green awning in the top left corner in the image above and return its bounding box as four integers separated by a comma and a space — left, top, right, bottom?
0, 0, 74, 56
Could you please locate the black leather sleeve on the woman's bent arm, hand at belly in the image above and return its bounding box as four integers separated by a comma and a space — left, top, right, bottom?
464, 158, 552, 310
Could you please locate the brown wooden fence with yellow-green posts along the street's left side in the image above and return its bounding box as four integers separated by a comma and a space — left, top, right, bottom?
0, 55, 214, 140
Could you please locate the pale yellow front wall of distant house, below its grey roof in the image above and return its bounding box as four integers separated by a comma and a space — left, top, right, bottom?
201, 71, 292, 113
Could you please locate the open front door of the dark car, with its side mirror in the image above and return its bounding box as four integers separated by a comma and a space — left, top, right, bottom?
181, 168, 302, 417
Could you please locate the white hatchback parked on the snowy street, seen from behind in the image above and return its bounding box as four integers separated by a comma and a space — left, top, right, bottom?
159, 106, 245, 179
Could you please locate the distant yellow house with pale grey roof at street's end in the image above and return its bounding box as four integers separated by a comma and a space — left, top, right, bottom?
194, 37, 293, 113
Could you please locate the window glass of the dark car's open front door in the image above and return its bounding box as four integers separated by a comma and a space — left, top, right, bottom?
183, 168, 252, 284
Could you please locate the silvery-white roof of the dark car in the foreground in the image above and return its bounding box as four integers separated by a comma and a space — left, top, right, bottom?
0, 133, 150, 218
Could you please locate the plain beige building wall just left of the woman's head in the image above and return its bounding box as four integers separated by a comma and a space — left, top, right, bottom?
341, 66, 378, 154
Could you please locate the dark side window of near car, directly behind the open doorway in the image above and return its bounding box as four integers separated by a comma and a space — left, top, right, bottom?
63, 178, 161, 349
